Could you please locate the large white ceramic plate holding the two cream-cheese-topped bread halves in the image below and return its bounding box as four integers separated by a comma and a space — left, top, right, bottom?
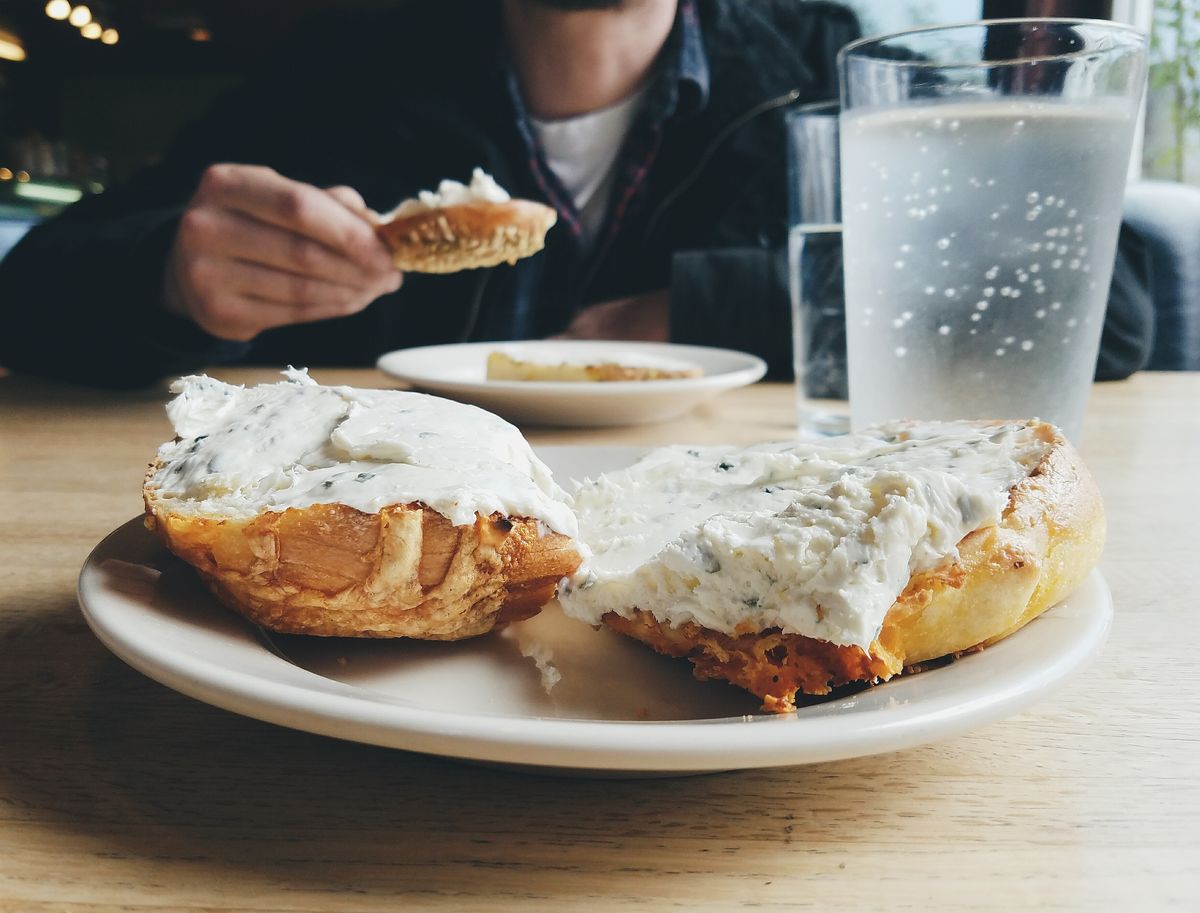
79, 448, 1112, 776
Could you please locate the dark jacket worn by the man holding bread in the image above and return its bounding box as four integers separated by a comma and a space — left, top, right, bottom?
0, 0, 1150, 385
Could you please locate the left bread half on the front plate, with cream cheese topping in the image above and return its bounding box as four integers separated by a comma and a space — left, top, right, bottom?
143, 374, 581, 641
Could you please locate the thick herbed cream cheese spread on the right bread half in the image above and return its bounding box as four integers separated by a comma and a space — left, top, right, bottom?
559, 422, 1048, 649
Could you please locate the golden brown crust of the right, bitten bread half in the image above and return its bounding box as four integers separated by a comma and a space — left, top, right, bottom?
604, 425, 1105, 713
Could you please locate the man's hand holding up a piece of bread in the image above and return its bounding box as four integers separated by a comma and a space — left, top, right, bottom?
163, 164, 401, 340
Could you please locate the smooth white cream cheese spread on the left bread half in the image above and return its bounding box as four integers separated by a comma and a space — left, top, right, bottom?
148, 370, 576, 536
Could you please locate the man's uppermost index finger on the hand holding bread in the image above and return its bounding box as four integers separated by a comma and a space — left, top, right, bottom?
199, 164, 390, 270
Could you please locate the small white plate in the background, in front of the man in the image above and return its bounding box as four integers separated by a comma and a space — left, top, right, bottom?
378, 340, 767, 426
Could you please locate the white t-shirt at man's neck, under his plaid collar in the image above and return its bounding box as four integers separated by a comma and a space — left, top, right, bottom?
529, 89, 646, 247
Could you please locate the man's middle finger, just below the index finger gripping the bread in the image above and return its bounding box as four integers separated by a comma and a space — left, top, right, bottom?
180, 206, 400, 290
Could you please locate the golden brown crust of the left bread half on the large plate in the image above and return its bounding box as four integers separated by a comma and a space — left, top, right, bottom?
145, 491, 580, 641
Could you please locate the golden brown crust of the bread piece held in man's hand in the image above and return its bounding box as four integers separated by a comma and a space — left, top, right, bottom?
376, 199, 558, 272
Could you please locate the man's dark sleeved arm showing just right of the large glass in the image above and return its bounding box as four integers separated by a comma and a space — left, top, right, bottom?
1096, 226, 1154, 380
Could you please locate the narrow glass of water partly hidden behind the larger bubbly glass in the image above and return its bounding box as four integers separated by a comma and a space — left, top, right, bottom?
787, 101, 850, 437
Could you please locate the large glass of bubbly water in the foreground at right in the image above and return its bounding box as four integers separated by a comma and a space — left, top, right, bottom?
840, 19, 1145, 440
